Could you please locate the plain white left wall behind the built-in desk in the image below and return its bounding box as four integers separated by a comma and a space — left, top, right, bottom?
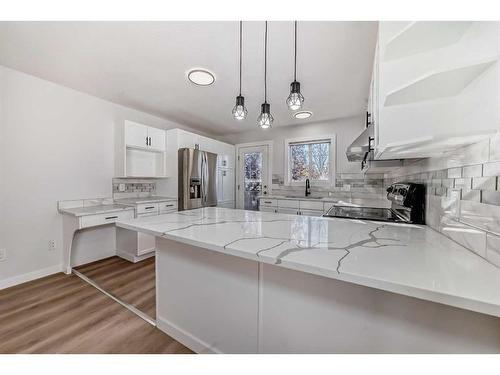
0, 66, 213, 286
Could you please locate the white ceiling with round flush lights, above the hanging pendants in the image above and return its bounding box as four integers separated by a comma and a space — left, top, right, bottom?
0, 21, 377, 134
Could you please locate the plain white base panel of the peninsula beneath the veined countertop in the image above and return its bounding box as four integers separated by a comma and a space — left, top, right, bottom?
156, 238, 500, 353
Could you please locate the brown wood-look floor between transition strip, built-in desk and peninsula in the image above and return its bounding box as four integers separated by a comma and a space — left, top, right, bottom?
75, 256, 156, 319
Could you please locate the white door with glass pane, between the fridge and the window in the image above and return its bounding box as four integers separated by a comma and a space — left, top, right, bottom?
236, 145, 269, 211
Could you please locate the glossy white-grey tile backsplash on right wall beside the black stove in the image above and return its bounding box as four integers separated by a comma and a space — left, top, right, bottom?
385, 133, 500, 267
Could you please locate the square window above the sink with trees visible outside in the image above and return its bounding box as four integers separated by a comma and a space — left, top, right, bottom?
285, 136, 334, 185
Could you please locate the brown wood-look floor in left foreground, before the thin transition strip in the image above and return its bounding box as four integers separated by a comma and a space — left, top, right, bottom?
0, 273, 191, 353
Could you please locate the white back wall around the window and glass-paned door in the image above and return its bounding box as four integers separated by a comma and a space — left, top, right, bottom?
222, 116, 364, 175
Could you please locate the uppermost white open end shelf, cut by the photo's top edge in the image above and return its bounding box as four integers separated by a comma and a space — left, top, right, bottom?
383, 21, 472, 61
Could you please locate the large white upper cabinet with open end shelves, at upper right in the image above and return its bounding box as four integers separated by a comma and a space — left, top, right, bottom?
369, 22, 500, 159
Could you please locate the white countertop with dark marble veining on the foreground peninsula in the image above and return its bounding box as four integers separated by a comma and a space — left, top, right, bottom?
116, 207, 500, 317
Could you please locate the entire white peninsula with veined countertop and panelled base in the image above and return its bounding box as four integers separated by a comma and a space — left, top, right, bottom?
116, 208, 500, 353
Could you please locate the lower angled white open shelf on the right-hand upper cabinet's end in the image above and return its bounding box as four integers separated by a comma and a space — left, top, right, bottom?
384, 59, 498, 107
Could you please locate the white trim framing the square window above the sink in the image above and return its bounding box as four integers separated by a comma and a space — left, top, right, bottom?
284, 134, 337, 187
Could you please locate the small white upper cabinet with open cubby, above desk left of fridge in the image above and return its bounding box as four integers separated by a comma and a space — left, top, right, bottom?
115, 120, 168, 178
